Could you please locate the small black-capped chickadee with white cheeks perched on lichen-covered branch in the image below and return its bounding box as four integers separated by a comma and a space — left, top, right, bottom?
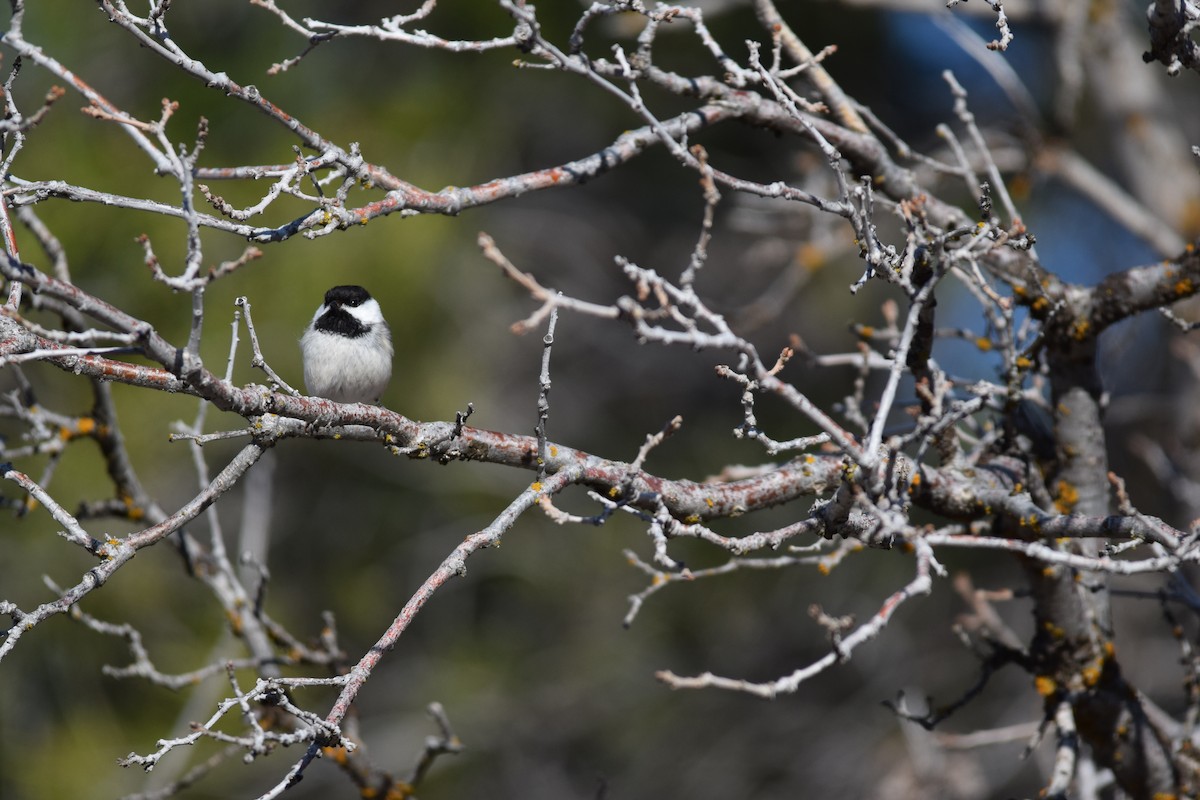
300, 285, 392, 403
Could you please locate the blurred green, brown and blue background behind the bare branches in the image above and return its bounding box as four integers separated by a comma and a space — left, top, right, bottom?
0, 0, 1200, 800
